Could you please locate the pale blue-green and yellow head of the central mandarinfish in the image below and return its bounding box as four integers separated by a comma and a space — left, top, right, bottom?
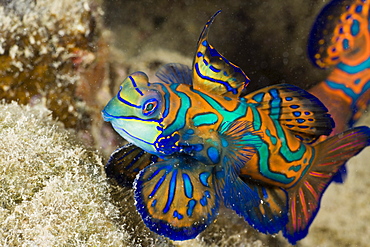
102, 72, 163, 154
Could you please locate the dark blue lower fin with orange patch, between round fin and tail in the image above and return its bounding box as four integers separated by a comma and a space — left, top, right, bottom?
222, 166, 288, 234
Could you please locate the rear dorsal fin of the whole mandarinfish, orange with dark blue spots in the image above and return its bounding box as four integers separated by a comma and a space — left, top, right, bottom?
245, 84, 334, 143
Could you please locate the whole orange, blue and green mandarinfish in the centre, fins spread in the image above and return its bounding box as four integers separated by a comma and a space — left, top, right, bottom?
103, 0, 370, 244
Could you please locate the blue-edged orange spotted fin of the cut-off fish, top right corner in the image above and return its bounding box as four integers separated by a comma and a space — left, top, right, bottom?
308, 0, 370, 68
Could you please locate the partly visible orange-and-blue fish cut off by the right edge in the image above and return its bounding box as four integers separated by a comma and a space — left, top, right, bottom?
308, 0, 370, 182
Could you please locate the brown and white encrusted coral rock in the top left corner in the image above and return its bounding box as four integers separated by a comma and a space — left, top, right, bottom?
0, 0, 100, 127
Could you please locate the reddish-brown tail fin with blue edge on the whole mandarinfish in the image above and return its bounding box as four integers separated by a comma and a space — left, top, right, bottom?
283, 126, 370, 244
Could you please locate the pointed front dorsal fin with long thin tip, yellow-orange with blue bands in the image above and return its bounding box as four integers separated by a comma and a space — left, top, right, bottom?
193, 11, 249, 97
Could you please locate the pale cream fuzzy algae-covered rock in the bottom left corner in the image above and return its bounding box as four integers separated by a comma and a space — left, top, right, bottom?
0, 103, 127, 246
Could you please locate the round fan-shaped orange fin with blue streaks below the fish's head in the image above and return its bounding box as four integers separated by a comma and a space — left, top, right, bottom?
134, 157, 219, 240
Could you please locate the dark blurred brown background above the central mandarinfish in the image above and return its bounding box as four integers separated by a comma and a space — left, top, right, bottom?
104, 0, 328, 91
